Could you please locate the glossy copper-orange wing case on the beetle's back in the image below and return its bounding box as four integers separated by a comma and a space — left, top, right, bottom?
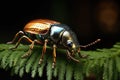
24, 19, 59, 35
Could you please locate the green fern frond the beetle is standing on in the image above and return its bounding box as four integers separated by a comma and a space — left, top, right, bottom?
0, 43, 120, 80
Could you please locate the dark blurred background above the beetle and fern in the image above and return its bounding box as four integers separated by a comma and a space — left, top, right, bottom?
0, 0, 120, 79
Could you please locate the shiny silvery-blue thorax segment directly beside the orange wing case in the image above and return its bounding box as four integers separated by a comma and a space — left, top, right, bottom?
50, 26, 65, 43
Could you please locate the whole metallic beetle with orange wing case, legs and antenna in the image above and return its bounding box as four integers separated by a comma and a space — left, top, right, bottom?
7, 19, 100, 68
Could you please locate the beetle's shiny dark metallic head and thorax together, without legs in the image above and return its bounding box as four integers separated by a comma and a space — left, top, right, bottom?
50, 24, 79, 49
